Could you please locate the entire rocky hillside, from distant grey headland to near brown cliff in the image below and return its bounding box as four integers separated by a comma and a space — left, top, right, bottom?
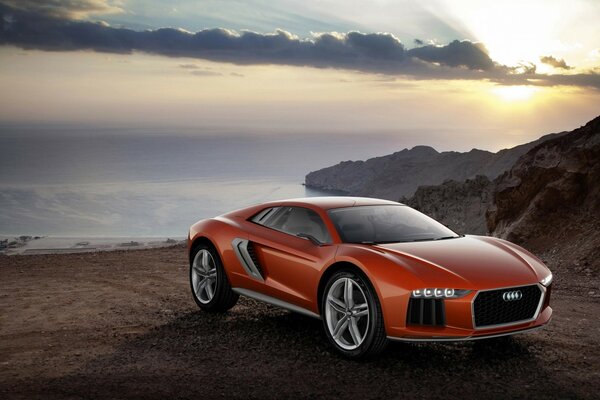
306, 117, 600, 270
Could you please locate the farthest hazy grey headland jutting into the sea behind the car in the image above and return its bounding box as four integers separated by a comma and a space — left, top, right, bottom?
305, 134, 561, 200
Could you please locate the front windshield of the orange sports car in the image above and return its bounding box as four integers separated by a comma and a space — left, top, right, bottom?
329, 205, 459, 243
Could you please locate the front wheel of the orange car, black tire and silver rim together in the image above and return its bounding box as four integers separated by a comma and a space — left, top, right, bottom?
321, 270, 387, 358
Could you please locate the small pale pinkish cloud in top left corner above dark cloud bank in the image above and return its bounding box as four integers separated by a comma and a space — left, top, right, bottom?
2, 0, 123, 19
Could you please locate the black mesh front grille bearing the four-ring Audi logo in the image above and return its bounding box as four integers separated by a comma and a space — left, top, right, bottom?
473, 285, 542, 328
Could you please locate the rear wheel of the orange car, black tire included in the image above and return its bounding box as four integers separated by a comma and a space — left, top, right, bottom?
190, 243, 239, 312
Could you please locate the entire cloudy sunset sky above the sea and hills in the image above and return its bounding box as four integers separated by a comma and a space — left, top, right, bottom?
0, 0, 600, 150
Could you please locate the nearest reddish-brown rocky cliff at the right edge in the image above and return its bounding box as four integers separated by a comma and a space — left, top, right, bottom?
487, 117, 600, 271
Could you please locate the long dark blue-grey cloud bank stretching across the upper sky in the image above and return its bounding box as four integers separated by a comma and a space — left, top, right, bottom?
0, 5, 491, 73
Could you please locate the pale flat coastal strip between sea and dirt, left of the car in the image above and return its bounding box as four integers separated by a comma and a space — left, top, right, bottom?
0, 235, 186, 256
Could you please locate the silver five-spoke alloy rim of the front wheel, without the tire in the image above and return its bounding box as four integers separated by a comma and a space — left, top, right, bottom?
325, 278, 369, 350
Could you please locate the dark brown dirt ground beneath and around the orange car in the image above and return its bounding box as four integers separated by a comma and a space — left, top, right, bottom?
0, 247, 600, 400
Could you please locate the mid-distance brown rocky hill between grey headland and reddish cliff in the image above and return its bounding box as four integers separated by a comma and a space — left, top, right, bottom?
400, 175, 494, 235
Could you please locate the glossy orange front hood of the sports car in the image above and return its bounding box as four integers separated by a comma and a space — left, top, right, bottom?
375, 236, 548, 289
